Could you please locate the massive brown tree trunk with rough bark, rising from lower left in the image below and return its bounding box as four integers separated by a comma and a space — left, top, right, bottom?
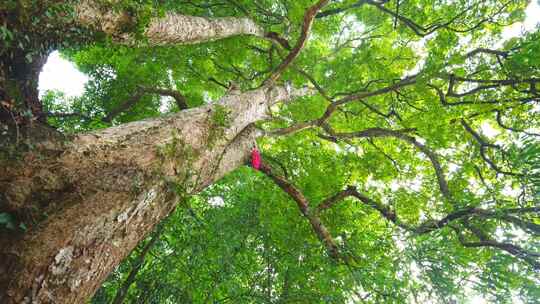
0, 83, 306, 303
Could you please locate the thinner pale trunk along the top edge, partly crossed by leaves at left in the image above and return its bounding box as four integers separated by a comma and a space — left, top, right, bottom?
76, 0, 264, 45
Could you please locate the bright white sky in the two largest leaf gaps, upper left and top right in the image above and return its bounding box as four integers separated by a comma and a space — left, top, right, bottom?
39, 0, 540, 96
